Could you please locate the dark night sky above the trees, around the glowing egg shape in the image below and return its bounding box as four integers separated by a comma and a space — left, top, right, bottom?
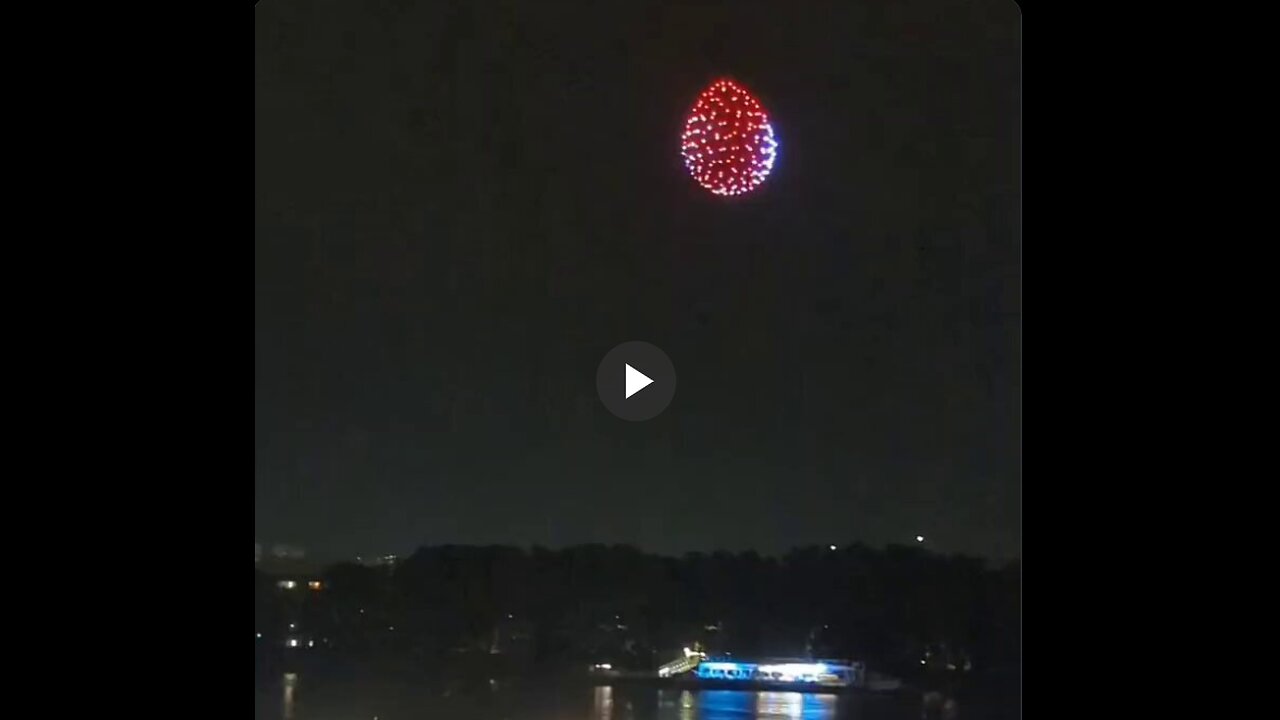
253, 0, 1021, 559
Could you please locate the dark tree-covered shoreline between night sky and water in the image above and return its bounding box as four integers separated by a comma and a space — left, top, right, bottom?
255, 544, 1021, 675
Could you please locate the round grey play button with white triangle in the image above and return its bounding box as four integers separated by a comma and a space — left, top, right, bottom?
595, 341, 676, 421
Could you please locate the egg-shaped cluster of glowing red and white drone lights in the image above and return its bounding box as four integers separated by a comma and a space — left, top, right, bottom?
680, 79, 778, 195
